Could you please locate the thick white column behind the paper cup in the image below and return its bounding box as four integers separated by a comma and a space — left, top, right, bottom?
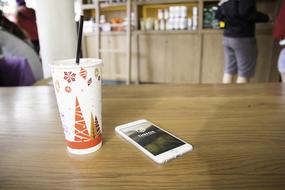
35, 0, 77, 78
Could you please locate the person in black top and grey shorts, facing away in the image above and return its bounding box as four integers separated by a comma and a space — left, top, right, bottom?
216, 0, 269, 84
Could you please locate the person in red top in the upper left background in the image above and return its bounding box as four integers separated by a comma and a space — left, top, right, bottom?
16, 0, 40, 54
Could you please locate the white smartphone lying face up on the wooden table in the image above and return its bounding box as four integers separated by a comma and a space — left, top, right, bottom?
115, 119, 193, 164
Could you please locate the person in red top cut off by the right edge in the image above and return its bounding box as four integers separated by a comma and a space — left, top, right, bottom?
273, 0, 285, 83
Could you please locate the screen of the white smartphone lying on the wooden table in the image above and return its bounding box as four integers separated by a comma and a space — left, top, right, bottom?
121, 122, 185, 156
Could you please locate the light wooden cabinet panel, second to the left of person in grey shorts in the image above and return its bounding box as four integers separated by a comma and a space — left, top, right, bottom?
165, 34, 201, 83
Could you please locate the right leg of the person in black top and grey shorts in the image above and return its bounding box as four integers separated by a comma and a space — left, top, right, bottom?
234, 38, 257, 84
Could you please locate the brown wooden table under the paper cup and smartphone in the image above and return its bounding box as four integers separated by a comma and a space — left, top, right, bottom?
0, 84, 285, 190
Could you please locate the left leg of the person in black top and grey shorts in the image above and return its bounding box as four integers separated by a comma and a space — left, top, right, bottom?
223, 37, 237, 84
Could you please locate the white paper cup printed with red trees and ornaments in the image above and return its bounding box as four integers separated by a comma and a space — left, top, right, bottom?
50, 59, 102, 154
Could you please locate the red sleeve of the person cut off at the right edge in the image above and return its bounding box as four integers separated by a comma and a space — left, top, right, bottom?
273, 0, 285, 40
